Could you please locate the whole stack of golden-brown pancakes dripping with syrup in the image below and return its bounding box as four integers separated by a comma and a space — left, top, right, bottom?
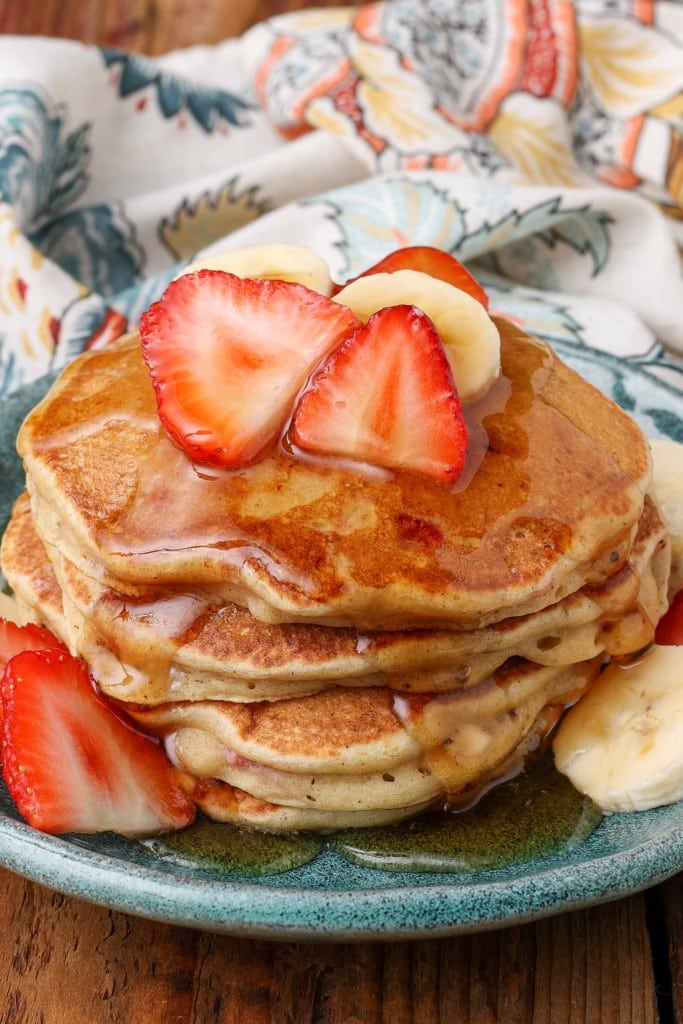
2, 322, 670, 829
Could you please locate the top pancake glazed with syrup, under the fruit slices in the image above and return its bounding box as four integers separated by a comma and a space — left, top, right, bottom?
17, 321, 650, 629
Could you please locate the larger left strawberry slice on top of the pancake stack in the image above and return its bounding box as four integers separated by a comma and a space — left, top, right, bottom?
140, 270, 359, 466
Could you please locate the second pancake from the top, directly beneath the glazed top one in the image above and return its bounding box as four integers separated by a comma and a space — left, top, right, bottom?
0, 496, 669, 705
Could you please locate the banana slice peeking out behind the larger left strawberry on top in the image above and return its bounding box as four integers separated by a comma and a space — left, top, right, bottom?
177, 244, 333, 297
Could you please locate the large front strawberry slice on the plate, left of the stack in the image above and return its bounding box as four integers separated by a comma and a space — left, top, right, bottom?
2, 650, 195, 835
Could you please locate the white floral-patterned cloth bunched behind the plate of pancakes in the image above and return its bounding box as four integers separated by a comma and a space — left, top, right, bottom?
0, 0, 683, 440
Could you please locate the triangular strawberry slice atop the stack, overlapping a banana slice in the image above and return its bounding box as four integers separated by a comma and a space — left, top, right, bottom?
291, 306, 467, 480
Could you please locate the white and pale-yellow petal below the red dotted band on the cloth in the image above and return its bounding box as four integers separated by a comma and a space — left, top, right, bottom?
489, 92, 592, 187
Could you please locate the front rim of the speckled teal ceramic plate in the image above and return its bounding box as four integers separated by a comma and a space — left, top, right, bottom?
0, 803, 683, 942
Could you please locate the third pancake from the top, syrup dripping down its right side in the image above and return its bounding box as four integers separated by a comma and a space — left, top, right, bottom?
124, 658, 600, 827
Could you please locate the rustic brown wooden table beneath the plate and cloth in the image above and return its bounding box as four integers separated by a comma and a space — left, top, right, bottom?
0, 0, 683, 1024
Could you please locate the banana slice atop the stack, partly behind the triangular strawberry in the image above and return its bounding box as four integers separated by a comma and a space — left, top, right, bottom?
334, 270, 501, 402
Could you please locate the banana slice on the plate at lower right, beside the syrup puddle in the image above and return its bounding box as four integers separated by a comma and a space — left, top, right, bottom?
553, 646, 683, 811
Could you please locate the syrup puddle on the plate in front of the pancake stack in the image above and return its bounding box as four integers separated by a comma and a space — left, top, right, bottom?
144, 756, 602, 879
